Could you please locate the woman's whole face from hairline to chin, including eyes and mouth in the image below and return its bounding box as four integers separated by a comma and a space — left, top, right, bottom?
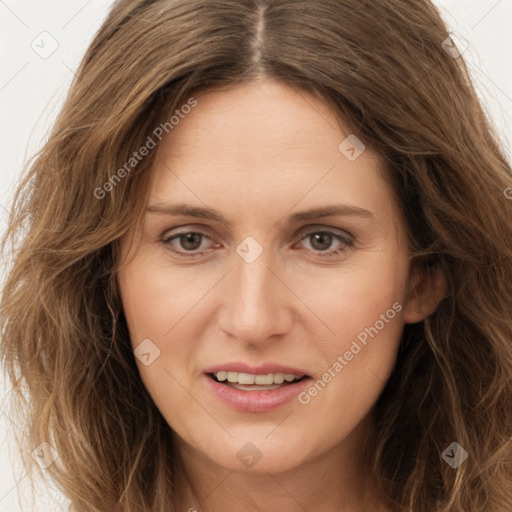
118, 80, 426, 472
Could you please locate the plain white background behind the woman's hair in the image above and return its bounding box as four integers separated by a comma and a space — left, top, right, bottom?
0, 0, 512, 512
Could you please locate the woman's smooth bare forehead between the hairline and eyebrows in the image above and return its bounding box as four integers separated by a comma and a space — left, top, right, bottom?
147, 80, 392, 224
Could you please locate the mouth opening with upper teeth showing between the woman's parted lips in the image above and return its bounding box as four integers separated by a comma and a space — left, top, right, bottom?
207, 370, 308, 391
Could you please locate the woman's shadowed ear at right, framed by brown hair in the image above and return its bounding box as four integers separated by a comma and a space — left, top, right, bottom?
404, 260, 446, 324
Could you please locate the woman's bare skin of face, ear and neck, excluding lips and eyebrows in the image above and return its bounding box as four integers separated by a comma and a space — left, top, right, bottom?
117, 79, 441, 512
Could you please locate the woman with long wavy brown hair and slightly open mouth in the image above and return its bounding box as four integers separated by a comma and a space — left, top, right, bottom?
0, 0, 512, 512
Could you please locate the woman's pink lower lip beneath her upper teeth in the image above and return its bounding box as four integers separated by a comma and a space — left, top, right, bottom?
204, 375, 311, 412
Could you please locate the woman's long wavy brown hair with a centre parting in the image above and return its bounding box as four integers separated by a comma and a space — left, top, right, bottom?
0, 0, 512, 512
